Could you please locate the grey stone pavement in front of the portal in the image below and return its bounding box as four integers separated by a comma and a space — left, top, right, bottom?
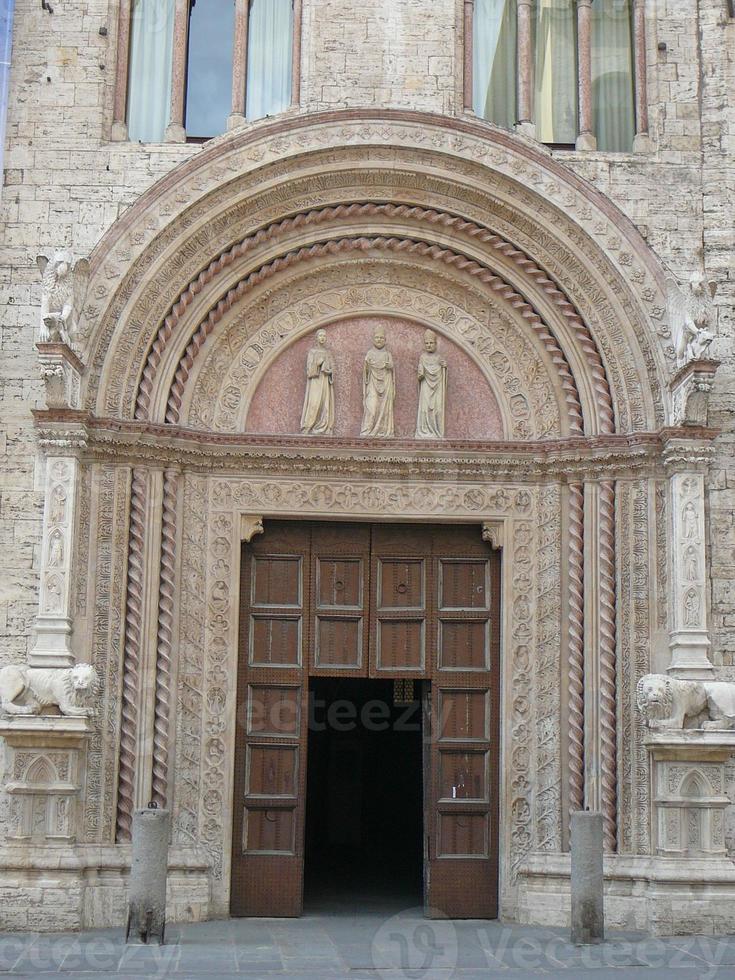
0, 909, 735, 980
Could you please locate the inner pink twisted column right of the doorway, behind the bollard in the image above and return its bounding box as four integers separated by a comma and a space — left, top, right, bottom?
568, 483, 584, 810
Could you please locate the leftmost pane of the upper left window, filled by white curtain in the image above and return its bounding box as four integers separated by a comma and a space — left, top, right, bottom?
128, 0, 175, 143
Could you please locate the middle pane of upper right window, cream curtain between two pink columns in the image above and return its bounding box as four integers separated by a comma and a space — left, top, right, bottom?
535, 0, 577, 143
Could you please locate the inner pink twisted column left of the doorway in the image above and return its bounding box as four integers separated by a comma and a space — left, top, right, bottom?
151, 470, 179, 807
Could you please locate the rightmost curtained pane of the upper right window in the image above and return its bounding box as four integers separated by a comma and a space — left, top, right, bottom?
592, 0, 635, 152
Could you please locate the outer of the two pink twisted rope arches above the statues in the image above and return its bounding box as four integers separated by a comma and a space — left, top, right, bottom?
135, 203, 615, 432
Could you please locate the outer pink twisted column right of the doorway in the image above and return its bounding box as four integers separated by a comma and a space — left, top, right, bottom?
599, 480, 618, 852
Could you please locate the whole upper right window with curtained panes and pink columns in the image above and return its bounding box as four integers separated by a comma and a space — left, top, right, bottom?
474, 0, 646, 152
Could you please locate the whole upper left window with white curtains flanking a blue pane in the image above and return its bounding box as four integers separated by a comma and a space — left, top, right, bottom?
122, 0, 301, 143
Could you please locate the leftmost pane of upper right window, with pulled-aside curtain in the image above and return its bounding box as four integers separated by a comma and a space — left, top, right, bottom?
472, 0, 518, 129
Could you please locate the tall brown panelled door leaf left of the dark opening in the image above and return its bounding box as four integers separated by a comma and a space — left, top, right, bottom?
231, 522, 310, 916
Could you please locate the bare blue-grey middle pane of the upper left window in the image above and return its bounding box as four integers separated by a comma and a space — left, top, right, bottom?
185, 0, 235, 139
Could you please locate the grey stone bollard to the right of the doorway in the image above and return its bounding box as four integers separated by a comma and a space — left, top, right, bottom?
570, 810, 605, 946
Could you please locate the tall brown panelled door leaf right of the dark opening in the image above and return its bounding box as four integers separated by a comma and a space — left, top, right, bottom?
425, 528, 500, 918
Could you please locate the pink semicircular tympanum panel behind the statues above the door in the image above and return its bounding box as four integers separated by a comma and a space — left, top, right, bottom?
245, 316, 504, 440
